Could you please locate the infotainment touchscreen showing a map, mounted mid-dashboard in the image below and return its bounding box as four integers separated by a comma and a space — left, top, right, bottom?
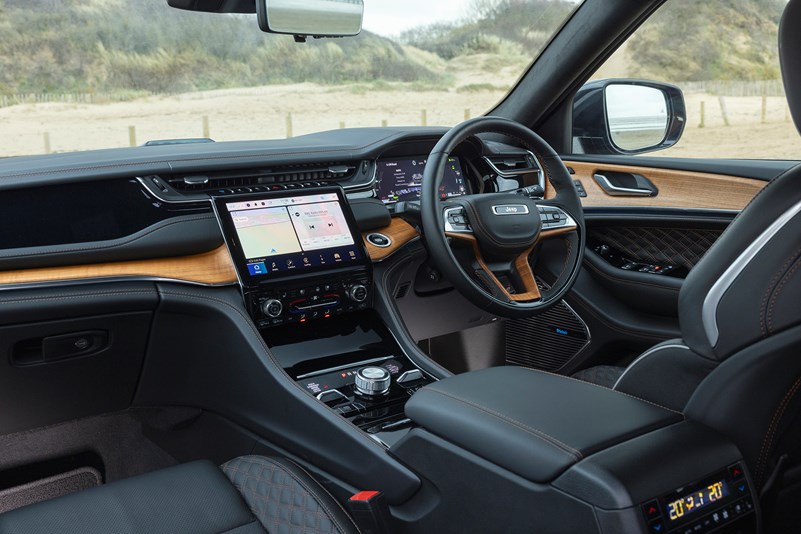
214, 188, 365, 285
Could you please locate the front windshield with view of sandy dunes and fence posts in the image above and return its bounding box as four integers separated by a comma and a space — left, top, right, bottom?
0, 0, 576, 156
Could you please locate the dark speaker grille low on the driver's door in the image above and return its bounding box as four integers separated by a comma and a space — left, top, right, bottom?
506, 302, 590, 371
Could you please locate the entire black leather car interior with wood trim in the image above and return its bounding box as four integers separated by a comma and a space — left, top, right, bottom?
0, 0, 801, 534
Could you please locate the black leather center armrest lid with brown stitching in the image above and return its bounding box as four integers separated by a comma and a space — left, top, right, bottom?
406, 367, 684, 482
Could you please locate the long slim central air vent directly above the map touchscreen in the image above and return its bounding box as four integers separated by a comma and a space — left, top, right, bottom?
162, 162, 361, 192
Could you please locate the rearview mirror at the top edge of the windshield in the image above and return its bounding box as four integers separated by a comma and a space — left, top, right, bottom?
256, 0, 364, 37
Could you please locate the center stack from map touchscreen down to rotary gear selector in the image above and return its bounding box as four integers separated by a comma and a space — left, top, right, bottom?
214, 187, 430, 442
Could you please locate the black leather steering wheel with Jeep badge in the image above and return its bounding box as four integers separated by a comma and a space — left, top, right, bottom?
420, 117, 585, 318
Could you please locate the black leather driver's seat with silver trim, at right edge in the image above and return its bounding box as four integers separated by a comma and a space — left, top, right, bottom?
574, 0, 801, 498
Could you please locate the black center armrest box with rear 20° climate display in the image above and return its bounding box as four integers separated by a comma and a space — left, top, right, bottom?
390, 367, 759, 534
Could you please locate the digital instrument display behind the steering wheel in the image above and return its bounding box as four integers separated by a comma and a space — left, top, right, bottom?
376, 158, 467, 204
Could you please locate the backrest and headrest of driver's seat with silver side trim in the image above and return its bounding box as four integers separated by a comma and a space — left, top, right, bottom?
679, 0, 801, 361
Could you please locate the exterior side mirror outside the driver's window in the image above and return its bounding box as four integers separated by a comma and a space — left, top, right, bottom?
573, 79, 687, 155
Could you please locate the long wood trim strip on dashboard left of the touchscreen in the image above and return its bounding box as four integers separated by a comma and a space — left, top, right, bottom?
0, 245, 237, 285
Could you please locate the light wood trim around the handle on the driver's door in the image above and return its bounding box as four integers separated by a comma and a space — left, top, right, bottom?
556, 160, 767, 211
